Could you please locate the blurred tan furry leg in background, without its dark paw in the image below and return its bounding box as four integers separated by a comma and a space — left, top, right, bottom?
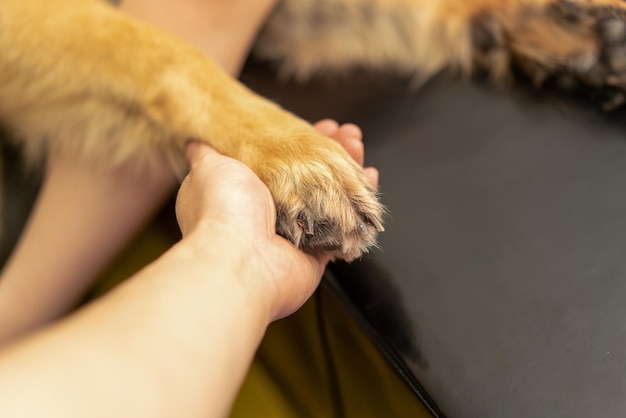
254, 0, 472, 80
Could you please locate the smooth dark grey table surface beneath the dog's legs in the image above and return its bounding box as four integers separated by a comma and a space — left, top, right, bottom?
244, 63, 626, 418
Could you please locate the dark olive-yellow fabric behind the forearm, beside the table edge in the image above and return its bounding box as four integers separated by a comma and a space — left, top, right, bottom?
92, 217, 430, 418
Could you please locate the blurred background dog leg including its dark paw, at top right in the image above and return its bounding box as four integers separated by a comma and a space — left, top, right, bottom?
255, 0, 626, 107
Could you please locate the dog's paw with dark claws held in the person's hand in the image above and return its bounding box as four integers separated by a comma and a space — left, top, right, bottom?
253, 129, 384, 261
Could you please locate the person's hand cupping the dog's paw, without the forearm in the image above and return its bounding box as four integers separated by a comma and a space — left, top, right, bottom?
176, 120, 378, 319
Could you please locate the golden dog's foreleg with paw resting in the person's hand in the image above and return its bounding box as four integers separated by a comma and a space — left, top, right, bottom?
0, 0, 382, 259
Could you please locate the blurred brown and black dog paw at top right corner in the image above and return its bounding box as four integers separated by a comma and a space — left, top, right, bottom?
472, 0, 626, 110
